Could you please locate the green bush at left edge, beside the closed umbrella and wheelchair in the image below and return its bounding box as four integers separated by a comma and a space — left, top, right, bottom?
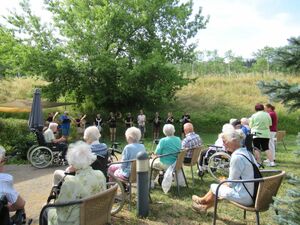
0, 118, 36, 159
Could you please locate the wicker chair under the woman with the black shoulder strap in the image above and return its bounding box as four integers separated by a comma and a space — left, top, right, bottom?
213, 170, 285, 225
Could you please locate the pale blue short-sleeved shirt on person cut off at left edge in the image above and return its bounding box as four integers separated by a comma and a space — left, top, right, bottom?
0, 173, 19, 204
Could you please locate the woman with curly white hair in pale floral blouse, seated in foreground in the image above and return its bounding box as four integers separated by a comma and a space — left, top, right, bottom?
44, 142, 106, 225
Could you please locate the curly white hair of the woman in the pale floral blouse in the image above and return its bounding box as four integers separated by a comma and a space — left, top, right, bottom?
67, 141, 96, 169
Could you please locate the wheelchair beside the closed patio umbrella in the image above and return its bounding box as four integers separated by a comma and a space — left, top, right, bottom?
27, 130, 64, 169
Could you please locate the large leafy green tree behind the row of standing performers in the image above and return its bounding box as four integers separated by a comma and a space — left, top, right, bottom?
2, 0, 208, 109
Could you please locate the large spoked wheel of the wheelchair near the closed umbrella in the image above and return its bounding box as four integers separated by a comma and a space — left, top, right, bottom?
29, 146, 53, 169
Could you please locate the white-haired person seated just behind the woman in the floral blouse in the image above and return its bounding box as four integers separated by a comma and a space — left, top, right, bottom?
83, 126, 108, 176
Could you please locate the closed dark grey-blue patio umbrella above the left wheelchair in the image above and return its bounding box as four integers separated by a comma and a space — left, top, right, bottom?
28, 89, 44, 130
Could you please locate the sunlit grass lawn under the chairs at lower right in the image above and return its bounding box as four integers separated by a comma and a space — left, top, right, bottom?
113, 134, 300, 225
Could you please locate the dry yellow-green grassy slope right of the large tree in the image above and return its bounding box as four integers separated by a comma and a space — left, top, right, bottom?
174, 74, 300, 133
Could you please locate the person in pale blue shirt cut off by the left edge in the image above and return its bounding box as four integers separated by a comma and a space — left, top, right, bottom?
0, 146, 25, 211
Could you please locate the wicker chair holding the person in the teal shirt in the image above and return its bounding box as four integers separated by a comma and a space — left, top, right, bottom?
149, 149, 188, 196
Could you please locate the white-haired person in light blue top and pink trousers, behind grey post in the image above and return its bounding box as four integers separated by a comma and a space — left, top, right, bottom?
108, 127, 146, 180
